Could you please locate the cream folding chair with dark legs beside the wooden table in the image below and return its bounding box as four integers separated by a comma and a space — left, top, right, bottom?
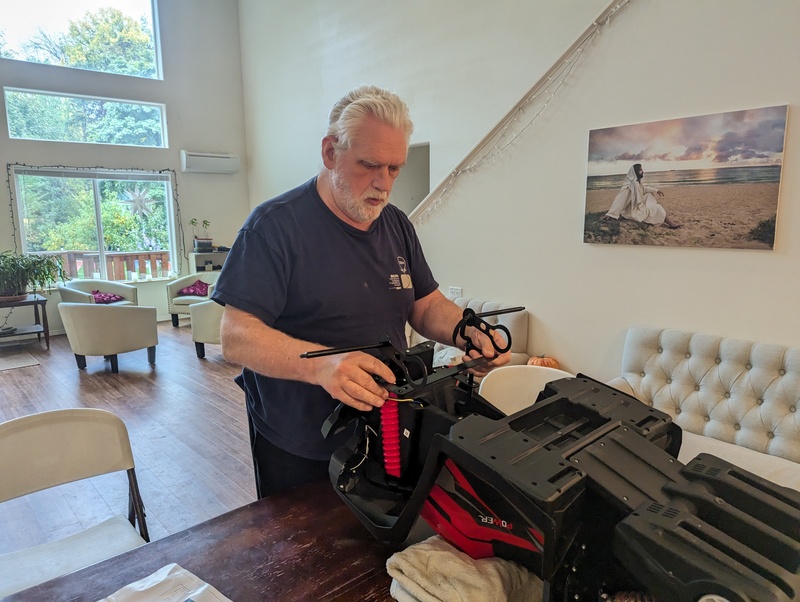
0, 408, 150, 598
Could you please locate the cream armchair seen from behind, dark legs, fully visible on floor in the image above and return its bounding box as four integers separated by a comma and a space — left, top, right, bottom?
58, 303, 158, 374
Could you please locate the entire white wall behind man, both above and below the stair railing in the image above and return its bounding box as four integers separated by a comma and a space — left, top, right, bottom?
240, 0, 800, 380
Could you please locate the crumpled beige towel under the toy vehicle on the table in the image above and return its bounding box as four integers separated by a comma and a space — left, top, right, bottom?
386, 535, 542, 602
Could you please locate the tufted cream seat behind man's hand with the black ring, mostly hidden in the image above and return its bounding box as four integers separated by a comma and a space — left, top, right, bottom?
407, 297, 531, 366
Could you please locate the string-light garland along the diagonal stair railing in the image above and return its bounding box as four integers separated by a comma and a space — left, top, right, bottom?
410, 0, 631, 224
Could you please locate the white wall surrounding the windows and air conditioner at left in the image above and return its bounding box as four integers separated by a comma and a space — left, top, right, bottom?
0, 0, 250, 332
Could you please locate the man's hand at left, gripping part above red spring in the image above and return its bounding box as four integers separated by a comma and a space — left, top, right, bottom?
314, 351, 395, 412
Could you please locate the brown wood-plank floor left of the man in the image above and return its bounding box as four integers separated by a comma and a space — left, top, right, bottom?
0, 320, 255, 553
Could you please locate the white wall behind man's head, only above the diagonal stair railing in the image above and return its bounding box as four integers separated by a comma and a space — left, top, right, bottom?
239, 0, 606, 206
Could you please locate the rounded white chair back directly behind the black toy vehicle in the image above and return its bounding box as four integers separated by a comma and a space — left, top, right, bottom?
478, 365, 575, 416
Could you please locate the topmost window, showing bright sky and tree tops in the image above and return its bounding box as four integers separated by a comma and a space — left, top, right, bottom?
0, 0, 161, 79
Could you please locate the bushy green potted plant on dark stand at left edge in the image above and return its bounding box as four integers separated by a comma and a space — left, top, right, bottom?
0, 251, 67, 300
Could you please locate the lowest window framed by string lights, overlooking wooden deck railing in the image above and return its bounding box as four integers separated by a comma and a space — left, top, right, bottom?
12, 167, 177, 281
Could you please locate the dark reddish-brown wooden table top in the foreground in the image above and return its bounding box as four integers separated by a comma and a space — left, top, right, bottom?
7, 481, 393, 602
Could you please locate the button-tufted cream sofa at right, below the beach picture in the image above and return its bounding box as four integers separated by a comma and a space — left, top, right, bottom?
608, 326, 800, 490
